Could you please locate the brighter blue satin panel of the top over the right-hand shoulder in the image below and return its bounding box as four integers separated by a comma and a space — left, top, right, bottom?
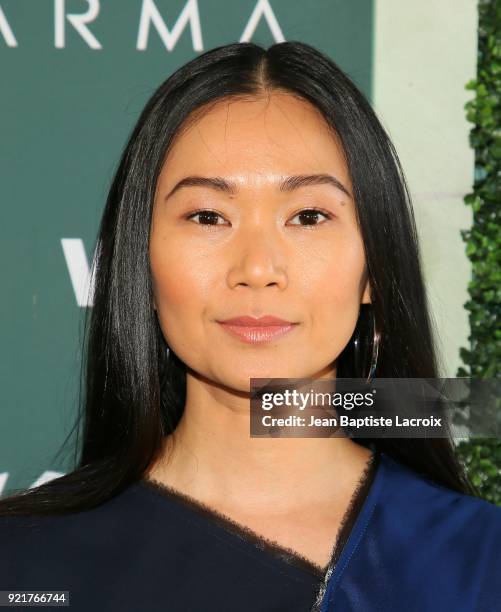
322, 453, 501, 612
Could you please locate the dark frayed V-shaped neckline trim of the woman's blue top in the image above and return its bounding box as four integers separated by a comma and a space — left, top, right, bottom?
137, 450, 380, 585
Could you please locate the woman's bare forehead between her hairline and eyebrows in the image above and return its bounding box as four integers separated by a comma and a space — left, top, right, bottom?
159, 92, 350, 187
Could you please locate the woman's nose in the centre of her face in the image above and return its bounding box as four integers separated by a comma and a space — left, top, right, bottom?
227, 228, 288, 290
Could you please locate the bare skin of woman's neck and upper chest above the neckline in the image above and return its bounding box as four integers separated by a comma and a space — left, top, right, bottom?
145, 378, 372, 568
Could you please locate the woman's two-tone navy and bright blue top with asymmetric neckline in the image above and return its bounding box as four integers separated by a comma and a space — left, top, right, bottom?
0, 453, 501, 612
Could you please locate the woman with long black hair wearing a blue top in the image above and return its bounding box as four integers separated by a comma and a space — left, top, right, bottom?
0, 42, 501, 612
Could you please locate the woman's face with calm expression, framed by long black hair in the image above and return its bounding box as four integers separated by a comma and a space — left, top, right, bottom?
149, 92, 369, 391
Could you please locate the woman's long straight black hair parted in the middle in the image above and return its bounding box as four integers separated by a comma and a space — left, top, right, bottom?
0, 41, 478, 515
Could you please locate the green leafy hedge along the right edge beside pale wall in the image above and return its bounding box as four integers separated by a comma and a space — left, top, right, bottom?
457, 0, 501, 506
